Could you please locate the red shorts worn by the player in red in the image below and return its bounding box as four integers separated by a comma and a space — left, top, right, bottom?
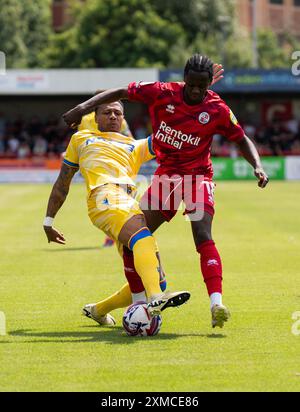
140, 174, 215, 221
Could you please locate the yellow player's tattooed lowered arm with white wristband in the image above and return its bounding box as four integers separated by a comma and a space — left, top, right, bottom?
44, 164, 78, 244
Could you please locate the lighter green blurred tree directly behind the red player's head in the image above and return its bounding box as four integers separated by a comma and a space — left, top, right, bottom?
152, 0, 252, 68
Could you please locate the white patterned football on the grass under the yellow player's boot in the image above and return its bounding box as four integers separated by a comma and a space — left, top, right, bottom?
123, 302, 162, 336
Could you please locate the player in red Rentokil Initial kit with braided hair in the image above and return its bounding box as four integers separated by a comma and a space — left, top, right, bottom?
63, 54, 268, 327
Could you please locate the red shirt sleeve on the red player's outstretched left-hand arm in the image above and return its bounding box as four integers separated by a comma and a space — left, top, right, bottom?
128, 82, 162, 104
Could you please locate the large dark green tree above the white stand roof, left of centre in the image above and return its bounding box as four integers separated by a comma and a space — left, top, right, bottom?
44, 0, 185, 67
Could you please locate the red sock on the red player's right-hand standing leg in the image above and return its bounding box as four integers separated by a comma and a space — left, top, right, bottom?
197, 240, 222, 296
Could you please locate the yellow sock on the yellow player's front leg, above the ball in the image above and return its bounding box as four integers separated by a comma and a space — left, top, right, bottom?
132, 236, 161, 297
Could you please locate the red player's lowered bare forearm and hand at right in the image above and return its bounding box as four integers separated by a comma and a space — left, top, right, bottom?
237, 136, 269, 189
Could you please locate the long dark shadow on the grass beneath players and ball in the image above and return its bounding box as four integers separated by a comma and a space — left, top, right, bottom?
4, 326, 226, 345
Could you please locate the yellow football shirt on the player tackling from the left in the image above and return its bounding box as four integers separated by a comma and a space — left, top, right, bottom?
63, 130, 155, 194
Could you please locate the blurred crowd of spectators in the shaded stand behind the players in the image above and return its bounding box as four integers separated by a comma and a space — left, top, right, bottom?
0, 114, 300, 159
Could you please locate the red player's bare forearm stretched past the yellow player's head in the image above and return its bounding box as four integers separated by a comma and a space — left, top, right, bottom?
62, 87, 128, 128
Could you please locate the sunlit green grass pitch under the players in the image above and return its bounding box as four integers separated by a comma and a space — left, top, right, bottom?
0, 181, 300, 392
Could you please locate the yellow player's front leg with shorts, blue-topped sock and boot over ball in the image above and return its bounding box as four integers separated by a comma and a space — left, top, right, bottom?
88, 185, 189, 320
